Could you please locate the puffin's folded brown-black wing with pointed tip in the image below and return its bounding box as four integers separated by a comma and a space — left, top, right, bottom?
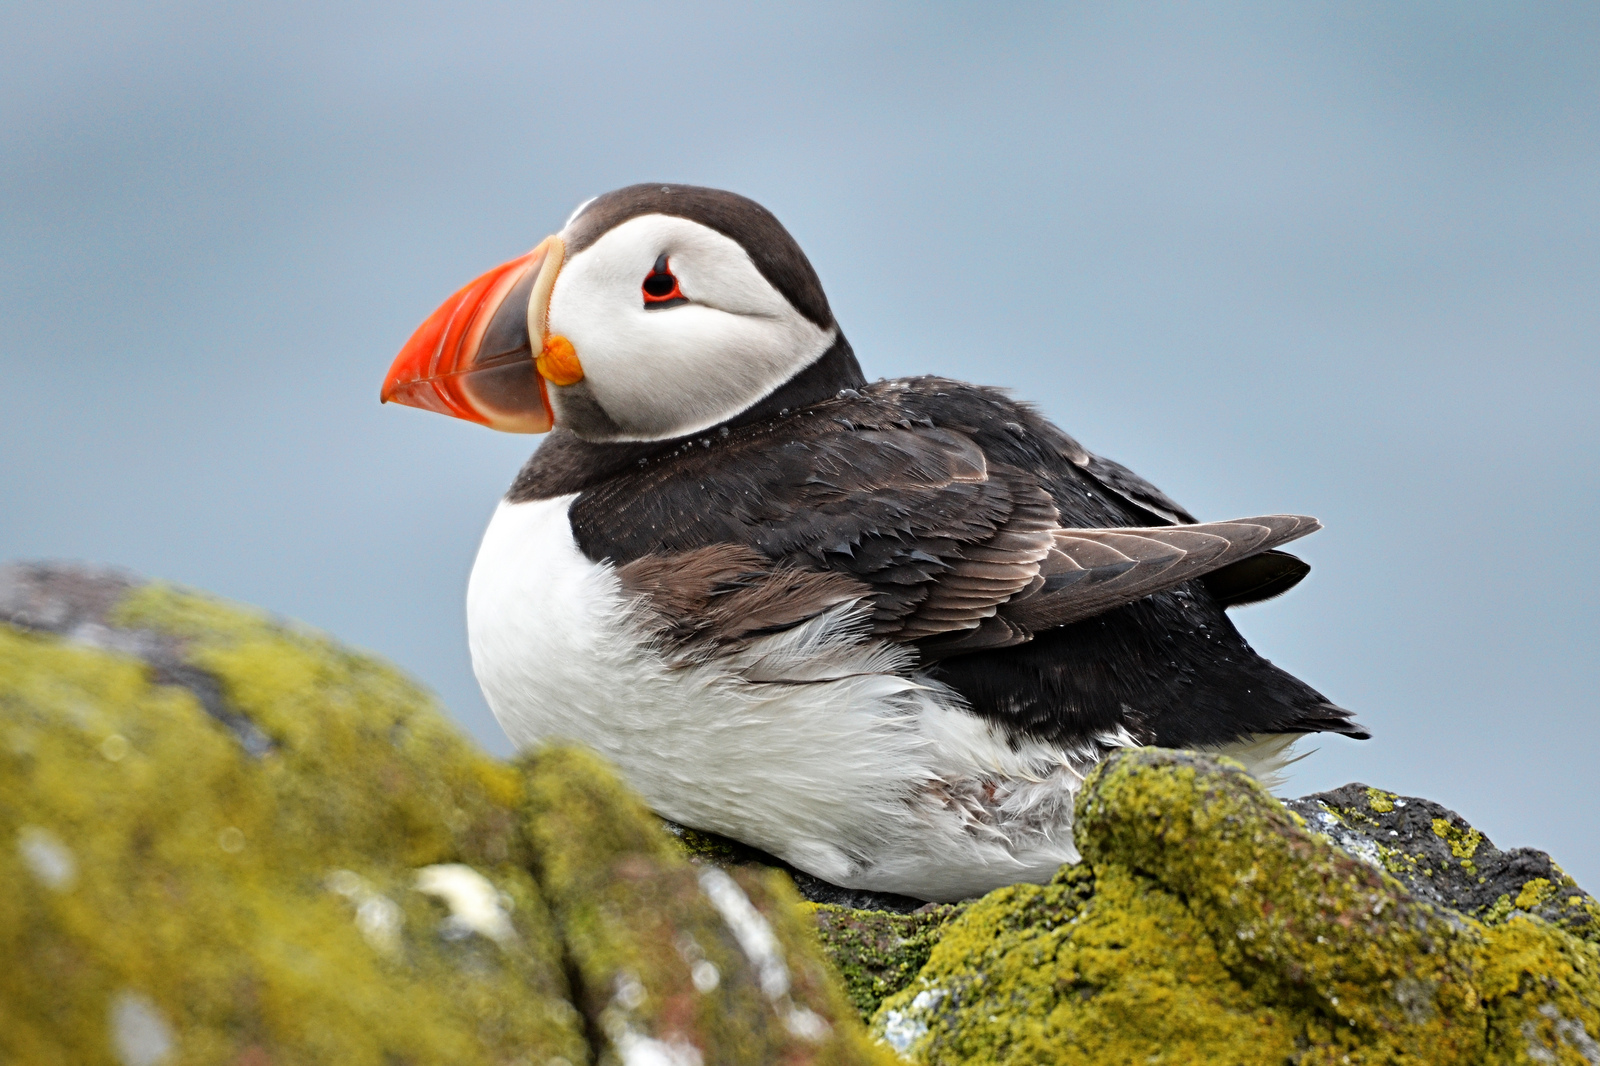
571, 421, 1317, 658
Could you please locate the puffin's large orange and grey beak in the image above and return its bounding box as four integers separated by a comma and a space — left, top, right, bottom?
379, 237, 582, 434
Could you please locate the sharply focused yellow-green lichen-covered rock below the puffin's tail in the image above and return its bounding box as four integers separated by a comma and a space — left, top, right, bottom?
874, 749, 1600, 1066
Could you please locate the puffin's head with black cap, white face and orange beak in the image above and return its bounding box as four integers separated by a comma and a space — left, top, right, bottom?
382, 184, 840, 442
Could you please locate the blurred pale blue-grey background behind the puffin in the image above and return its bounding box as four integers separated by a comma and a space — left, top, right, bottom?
0, 2, 1600, 890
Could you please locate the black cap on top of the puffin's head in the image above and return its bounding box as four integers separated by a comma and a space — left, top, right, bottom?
563, 182, 834, 330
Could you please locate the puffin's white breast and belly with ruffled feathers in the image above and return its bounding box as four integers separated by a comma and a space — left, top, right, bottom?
467, 496, 1286, 900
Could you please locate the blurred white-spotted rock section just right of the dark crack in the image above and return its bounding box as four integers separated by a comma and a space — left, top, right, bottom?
525, 749, 880, 1066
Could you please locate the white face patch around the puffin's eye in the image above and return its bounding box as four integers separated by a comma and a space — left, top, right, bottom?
549, 214, 838, 440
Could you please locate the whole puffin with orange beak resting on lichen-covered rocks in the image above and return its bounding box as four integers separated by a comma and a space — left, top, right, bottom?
381, 184, 1368, 901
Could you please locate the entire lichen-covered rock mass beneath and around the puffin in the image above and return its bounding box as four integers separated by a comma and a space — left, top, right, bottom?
0, 567, 1600, 1066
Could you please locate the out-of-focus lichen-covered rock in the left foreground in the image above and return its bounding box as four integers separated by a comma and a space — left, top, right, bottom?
0, 567, 883, 1066
